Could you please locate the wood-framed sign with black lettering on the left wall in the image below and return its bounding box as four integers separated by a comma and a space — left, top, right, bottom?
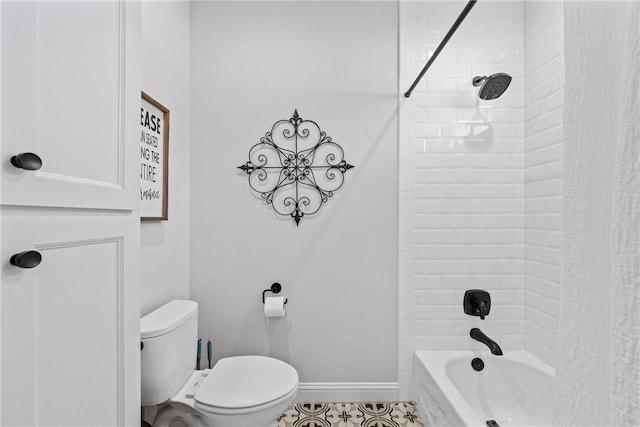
140, 92, 169, 221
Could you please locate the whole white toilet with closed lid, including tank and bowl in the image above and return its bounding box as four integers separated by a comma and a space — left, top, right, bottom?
140, 300, 298, 427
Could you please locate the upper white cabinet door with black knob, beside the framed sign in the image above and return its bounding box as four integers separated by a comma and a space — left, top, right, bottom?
0, 0, 140, 210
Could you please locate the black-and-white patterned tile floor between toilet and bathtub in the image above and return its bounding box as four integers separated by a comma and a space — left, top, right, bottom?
278, 402, 424, 427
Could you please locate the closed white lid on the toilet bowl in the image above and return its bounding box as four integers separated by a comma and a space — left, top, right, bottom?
194, 356, 298, 408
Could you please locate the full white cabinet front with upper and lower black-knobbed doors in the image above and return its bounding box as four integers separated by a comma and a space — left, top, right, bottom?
0, 0, 140, 426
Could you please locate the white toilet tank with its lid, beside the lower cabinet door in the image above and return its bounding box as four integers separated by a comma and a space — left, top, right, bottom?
140, 300, 198, 406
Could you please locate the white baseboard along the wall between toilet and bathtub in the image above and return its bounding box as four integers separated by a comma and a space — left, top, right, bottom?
296, 382, 399, 402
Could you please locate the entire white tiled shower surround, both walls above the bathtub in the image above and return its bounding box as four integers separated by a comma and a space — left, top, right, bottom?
399, 1, 564, 398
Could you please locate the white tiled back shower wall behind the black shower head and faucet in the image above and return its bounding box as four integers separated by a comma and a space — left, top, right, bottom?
399, 1, 525, 397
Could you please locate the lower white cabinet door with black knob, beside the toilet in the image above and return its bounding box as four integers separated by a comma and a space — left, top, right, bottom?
0, 209, 140, 426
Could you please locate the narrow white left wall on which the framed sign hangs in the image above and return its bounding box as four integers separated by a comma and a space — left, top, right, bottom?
140, 1, 190, 315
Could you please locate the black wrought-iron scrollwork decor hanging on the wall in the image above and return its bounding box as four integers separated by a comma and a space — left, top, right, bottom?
238, 110, 353, 225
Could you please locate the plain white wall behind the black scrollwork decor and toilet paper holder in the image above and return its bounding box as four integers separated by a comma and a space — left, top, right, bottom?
190, 2, 398, 383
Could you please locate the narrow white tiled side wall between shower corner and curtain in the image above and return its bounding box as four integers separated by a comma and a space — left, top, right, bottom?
524, 1, 565, 366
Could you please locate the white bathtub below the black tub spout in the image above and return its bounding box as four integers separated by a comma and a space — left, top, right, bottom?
411, 351, 555, 427
